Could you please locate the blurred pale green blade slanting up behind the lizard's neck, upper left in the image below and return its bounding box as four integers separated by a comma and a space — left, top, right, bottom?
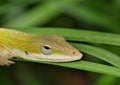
3, 2, 59, 27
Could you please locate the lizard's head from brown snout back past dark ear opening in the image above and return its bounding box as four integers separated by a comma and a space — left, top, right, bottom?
13, 35, 82, 62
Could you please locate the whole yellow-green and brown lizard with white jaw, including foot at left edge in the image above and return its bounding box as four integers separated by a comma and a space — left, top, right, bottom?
0, 28, 82, 66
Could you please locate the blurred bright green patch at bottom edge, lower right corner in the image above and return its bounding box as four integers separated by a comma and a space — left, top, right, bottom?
94, 75, 117, 85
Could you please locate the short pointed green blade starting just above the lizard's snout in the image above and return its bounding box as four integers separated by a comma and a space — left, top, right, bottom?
71, 43, 120, 68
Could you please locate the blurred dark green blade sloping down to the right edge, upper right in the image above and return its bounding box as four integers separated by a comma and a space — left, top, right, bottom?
64, 5, 120, 33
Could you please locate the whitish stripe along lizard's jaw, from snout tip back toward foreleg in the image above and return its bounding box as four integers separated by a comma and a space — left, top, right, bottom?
12, 49, 83, 62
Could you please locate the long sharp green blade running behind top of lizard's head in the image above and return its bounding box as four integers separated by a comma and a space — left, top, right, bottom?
14, 27, 120, 46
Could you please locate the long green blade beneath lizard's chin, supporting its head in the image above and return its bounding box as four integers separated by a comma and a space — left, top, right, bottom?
13, 59, 120, 78
